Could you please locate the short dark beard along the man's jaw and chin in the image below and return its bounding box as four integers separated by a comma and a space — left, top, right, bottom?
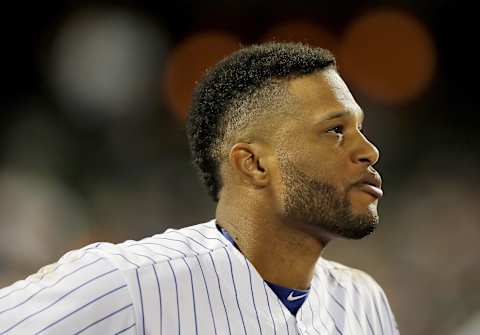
279, 155, 379, 240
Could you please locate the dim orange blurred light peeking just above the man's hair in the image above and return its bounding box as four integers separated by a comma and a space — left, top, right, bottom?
260, 20, 337, 53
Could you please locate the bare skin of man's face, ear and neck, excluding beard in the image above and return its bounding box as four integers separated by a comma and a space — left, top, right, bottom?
216, 68, 381, 289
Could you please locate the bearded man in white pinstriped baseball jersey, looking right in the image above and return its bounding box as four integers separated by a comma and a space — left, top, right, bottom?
0, 43, 399, 335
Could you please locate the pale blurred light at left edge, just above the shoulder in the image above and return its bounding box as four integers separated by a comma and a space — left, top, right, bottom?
0, 170, 91, 271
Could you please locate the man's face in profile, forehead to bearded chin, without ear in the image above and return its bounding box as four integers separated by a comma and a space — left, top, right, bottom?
275, 69, 381, 239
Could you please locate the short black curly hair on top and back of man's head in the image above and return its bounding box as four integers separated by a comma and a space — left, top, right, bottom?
187, 42, 336, 201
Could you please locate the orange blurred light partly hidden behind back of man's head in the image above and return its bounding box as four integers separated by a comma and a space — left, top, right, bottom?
164, 31, 240, 120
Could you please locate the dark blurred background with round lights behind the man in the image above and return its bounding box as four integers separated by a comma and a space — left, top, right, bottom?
0, 0, 480, 335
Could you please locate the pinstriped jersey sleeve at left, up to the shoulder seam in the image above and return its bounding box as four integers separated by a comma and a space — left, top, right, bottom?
0, 245, 135, 334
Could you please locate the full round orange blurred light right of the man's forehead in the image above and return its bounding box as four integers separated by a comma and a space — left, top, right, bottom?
337, 9, 436, 103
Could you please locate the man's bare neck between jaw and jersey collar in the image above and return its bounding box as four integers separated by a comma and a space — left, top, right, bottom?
216, 193, 325, 290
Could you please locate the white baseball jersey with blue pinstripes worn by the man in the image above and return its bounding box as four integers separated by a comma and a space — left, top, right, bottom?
0, 220, 399, 335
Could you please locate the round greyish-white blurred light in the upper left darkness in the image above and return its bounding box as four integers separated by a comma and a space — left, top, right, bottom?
48, 9, 167, 119
